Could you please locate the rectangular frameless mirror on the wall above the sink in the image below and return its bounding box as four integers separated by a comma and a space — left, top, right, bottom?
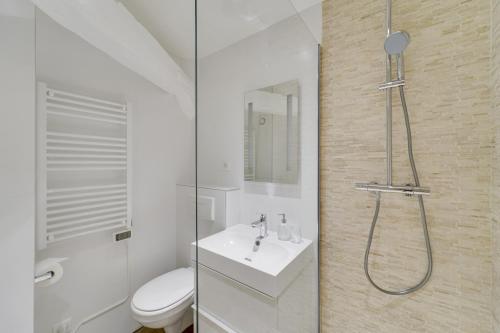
244, 80, 300, 184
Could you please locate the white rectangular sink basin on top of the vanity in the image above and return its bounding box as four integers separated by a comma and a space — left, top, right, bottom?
191, 224, 313, 297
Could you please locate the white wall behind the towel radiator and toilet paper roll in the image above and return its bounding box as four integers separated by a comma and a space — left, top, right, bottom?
35, 12, 193, 333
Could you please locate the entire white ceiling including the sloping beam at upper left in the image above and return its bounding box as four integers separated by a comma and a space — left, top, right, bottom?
30, 0, 321, 115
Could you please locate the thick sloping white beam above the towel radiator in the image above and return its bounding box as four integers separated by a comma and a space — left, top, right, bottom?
32, 0, 194, 117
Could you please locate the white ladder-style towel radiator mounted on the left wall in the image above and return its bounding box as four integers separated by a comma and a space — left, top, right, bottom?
37, 82, 131, 249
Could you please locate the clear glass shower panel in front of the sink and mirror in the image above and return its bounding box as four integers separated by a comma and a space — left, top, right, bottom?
193, 0, 321, 333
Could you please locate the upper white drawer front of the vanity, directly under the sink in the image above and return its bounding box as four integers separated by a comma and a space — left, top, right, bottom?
198, 264, 278, 333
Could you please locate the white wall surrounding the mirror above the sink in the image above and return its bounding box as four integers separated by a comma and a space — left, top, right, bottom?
198, 17, 318, 239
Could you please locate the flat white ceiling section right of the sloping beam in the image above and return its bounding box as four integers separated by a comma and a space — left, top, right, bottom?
120, 0, 322, 59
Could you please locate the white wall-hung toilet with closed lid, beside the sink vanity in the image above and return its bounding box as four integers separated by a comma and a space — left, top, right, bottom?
130, 267, 194, 333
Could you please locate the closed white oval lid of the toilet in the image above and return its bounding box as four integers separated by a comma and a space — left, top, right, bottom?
132, 268, 194, 311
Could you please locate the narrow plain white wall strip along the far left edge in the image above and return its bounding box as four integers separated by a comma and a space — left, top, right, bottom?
0, 0, 35, 333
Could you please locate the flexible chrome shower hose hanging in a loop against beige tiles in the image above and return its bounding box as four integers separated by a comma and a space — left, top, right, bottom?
364, 86, 432, 295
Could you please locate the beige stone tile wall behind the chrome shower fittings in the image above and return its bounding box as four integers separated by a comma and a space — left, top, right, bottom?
320, 0, 494, 333
